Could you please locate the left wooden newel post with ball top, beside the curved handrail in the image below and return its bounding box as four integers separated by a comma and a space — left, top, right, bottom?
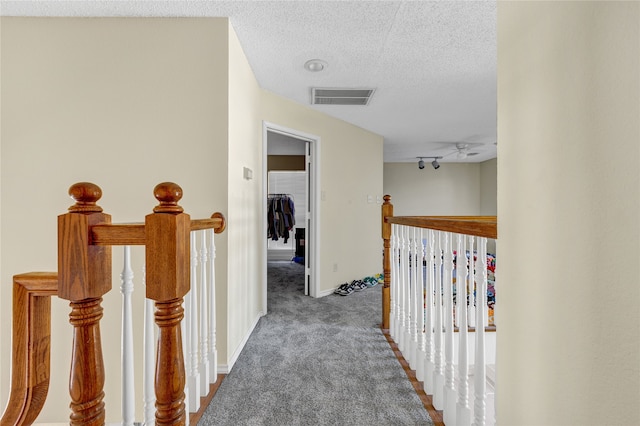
58, 182, 111, 425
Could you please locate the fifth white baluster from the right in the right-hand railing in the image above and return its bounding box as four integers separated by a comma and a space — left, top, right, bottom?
424, 229, 436, 395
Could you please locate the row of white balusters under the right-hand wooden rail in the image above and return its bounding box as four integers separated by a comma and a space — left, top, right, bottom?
389, 224, 495, 426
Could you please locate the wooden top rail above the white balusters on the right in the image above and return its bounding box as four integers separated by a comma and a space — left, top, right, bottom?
384, 216, 498, 239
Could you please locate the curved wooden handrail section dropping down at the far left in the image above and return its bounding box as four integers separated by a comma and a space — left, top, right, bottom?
0, 272, 58, 426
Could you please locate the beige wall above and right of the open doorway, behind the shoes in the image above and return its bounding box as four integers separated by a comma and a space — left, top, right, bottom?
262, 91, 383, 292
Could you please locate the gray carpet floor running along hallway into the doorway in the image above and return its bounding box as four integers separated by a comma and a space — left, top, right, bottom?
198, 262, 433, 426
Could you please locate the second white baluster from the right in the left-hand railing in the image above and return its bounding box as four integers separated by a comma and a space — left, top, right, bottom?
198, 230, 211, 396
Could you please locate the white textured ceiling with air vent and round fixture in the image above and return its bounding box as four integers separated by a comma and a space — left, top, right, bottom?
0, 0, 496, 162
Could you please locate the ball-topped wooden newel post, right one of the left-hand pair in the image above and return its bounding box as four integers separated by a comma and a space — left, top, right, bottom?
145, 182, 191, 425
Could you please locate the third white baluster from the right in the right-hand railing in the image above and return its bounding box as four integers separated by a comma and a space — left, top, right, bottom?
442, 232, 456, 425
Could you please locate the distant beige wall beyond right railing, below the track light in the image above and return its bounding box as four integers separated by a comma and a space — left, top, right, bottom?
384, 162, 496, 216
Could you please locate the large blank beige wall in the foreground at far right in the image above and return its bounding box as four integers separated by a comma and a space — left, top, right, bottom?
497, 2, 640, 425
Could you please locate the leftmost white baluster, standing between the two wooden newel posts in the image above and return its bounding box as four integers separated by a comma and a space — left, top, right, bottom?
120, 246, 136, 426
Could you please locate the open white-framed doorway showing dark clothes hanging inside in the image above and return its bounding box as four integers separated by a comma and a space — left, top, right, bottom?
263, 123, 319, 313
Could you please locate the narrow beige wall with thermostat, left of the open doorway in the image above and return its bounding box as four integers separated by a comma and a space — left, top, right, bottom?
222, 27, 266, 361
